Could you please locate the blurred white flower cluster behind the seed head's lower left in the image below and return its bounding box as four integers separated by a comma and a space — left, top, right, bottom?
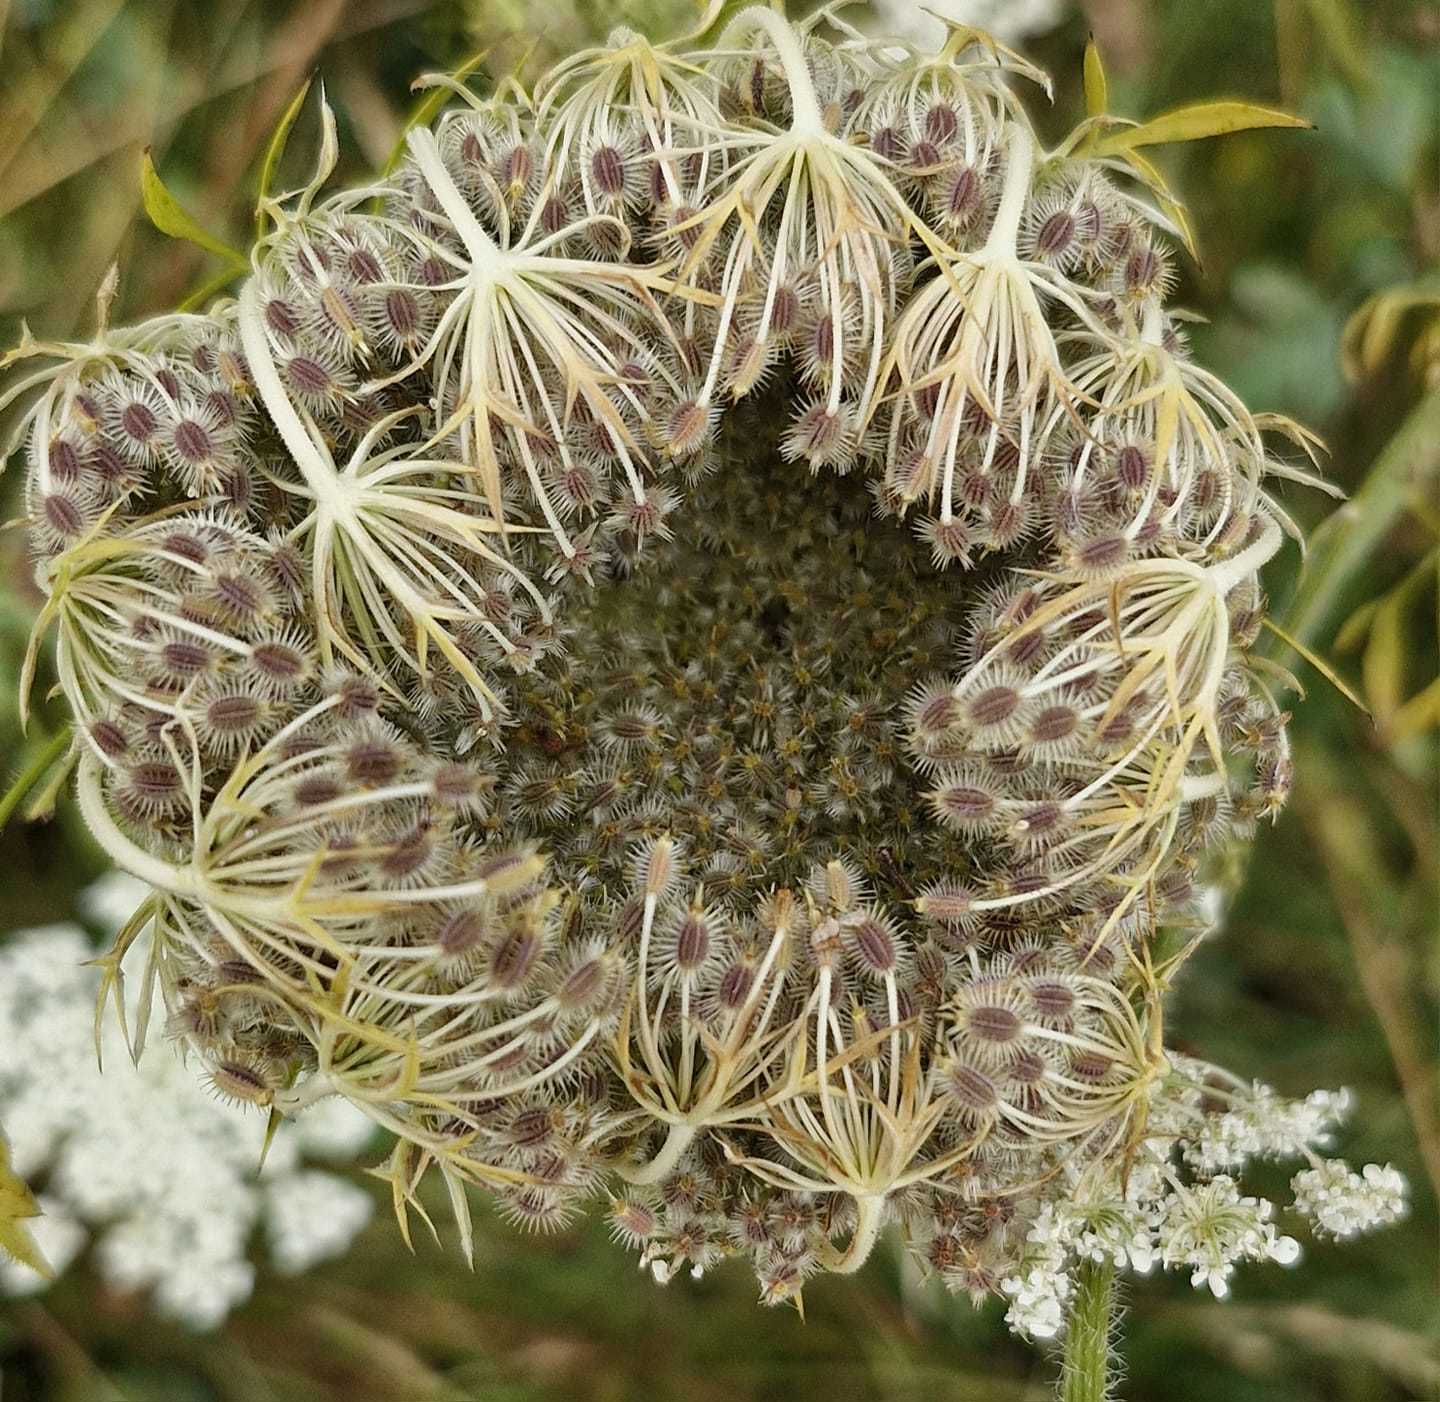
0, 878, 372, 1329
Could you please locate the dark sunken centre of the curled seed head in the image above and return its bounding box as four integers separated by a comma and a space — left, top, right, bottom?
492, 406, 975, 900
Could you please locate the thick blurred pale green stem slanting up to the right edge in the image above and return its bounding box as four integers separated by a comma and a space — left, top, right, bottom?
1276, 390, 1440, 666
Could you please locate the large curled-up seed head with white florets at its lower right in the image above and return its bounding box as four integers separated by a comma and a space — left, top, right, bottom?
7, 7, 1403, 1333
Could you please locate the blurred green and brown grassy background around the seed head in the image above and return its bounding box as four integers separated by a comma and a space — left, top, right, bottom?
0, 0, 1440, 1402
